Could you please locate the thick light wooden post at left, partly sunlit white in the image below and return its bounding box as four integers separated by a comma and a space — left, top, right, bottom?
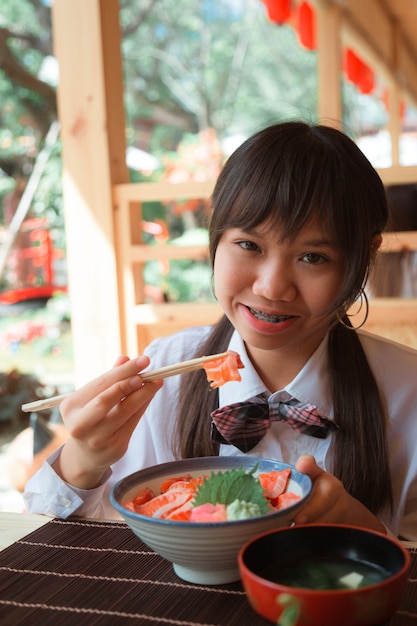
53, 0, 128, 386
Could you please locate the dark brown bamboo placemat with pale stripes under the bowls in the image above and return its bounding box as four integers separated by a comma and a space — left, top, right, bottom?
0, 520, 417, 626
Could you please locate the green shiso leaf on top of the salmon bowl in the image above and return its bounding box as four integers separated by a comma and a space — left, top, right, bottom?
193, 465, 270, 515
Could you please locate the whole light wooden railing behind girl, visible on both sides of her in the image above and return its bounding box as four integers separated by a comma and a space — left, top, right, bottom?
113, 173, 417, 354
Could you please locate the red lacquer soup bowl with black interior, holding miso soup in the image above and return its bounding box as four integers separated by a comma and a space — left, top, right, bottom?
238, 524, 410, 626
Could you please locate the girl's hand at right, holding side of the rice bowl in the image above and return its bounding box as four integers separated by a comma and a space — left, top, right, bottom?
294, 455, 386, 533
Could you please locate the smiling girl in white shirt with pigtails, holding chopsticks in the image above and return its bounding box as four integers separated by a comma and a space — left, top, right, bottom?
25, 122, 417, 540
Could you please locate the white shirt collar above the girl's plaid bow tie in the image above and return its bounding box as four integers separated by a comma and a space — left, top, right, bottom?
219, 331, 333, 419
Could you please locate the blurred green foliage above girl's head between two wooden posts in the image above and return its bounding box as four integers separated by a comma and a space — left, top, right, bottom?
120, 0, 317, 154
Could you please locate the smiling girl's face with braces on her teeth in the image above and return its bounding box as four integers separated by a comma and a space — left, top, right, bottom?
214, 214, 344, 380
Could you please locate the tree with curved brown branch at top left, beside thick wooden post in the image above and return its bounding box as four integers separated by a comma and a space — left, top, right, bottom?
0, 0, 57, 176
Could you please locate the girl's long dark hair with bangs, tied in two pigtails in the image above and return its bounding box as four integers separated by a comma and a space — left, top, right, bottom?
176, 122, 392, 512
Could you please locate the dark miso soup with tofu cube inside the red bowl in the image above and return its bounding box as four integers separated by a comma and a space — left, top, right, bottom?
259, 558, 390, 590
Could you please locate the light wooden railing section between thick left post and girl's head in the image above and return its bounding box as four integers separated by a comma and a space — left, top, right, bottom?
113, 182, 221, 354
